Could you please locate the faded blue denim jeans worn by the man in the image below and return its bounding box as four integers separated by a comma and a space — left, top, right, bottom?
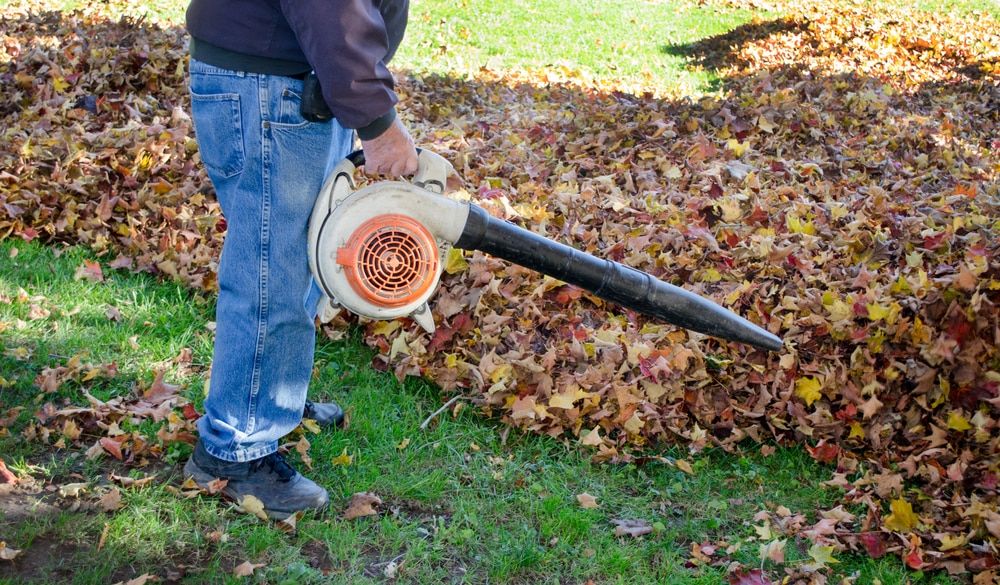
190, 59, 354, 462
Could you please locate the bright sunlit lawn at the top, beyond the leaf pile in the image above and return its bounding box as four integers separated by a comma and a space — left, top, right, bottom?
396, 0, 766, 94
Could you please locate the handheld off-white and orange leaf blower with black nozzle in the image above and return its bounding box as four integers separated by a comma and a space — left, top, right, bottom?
309, 149, 782, 351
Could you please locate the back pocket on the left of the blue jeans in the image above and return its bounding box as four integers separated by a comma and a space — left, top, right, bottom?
191, 91, 246, 179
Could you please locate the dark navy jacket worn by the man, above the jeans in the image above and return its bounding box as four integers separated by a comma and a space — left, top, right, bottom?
187, 0, 409, 135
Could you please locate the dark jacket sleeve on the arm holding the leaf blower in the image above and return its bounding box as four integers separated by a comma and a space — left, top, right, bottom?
280, 0, 407, 133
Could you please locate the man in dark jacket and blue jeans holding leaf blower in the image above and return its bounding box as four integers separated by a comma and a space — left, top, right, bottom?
184, 0, 417, 519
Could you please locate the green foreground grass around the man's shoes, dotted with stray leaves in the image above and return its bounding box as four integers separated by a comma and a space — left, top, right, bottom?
0, 240, 949, 584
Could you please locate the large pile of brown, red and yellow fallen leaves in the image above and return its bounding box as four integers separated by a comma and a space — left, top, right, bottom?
0, 3, 1000, 583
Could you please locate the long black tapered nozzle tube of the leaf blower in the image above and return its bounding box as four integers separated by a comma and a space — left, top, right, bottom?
455, 205, 783, 351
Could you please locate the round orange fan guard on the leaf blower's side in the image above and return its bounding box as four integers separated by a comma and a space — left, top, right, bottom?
337, 214, 438, 307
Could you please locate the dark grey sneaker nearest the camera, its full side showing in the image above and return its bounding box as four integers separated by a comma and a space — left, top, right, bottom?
184, 441, 330, 520
